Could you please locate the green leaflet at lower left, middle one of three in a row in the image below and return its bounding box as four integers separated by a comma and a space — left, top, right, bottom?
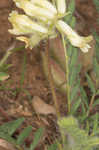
17, 126, 32, 145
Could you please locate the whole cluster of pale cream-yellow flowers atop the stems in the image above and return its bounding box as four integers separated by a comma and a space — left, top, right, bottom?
8, 0, 92, 52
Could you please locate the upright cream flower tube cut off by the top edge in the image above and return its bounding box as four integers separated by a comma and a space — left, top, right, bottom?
57, 0, 66, 14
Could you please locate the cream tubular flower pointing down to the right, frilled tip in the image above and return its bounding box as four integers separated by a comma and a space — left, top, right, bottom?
56, 20, 93, 53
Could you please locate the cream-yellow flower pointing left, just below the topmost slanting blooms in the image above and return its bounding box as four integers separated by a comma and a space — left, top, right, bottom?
8, 11, 48, 35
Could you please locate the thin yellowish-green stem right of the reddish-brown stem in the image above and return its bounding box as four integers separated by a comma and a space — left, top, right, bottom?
61, 34, 71, 113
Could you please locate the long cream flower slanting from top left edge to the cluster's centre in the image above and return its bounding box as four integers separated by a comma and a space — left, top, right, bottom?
14, 0, 55, 20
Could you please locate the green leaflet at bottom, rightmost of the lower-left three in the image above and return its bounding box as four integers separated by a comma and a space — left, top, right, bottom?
29, 128, 44, 150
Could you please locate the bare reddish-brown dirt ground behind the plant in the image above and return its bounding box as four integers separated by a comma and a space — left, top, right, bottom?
0, 0, 99, 149
